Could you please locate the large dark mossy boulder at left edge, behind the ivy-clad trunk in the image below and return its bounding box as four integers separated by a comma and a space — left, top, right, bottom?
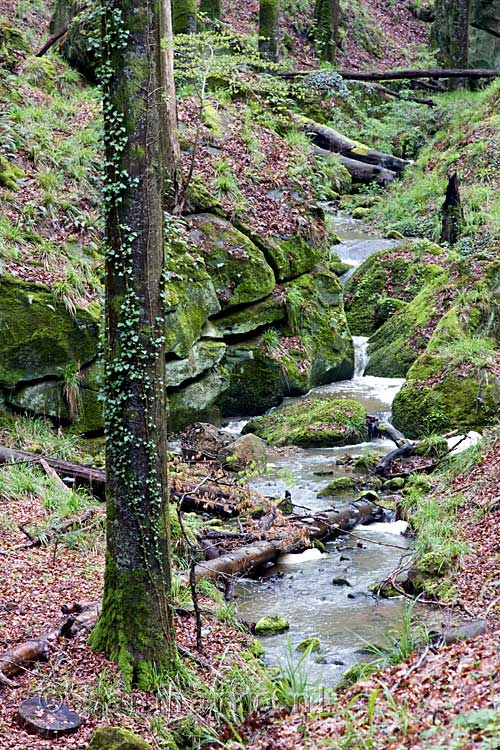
0, 276, 99, 387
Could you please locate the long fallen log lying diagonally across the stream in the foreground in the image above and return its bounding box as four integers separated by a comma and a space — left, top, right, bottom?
187, 500, 384, 581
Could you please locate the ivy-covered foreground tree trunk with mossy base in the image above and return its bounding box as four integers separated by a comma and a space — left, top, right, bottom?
91, 0, 180, 688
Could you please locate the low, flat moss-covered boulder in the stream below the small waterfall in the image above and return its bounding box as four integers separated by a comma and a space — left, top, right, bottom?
244, 398, 367, 448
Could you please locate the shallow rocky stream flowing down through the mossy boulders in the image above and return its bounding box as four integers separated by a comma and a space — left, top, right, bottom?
228, 216, 424, 686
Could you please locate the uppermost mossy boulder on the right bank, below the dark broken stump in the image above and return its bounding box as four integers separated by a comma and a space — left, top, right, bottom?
345, 240, 445, 336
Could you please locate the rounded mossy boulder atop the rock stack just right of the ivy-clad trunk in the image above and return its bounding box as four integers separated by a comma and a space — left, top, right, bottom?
187, 214, 276, 310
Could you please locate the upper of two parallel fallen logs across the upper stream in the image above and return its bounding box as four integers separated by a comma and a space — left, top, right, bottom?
294, 116, 410, 174
